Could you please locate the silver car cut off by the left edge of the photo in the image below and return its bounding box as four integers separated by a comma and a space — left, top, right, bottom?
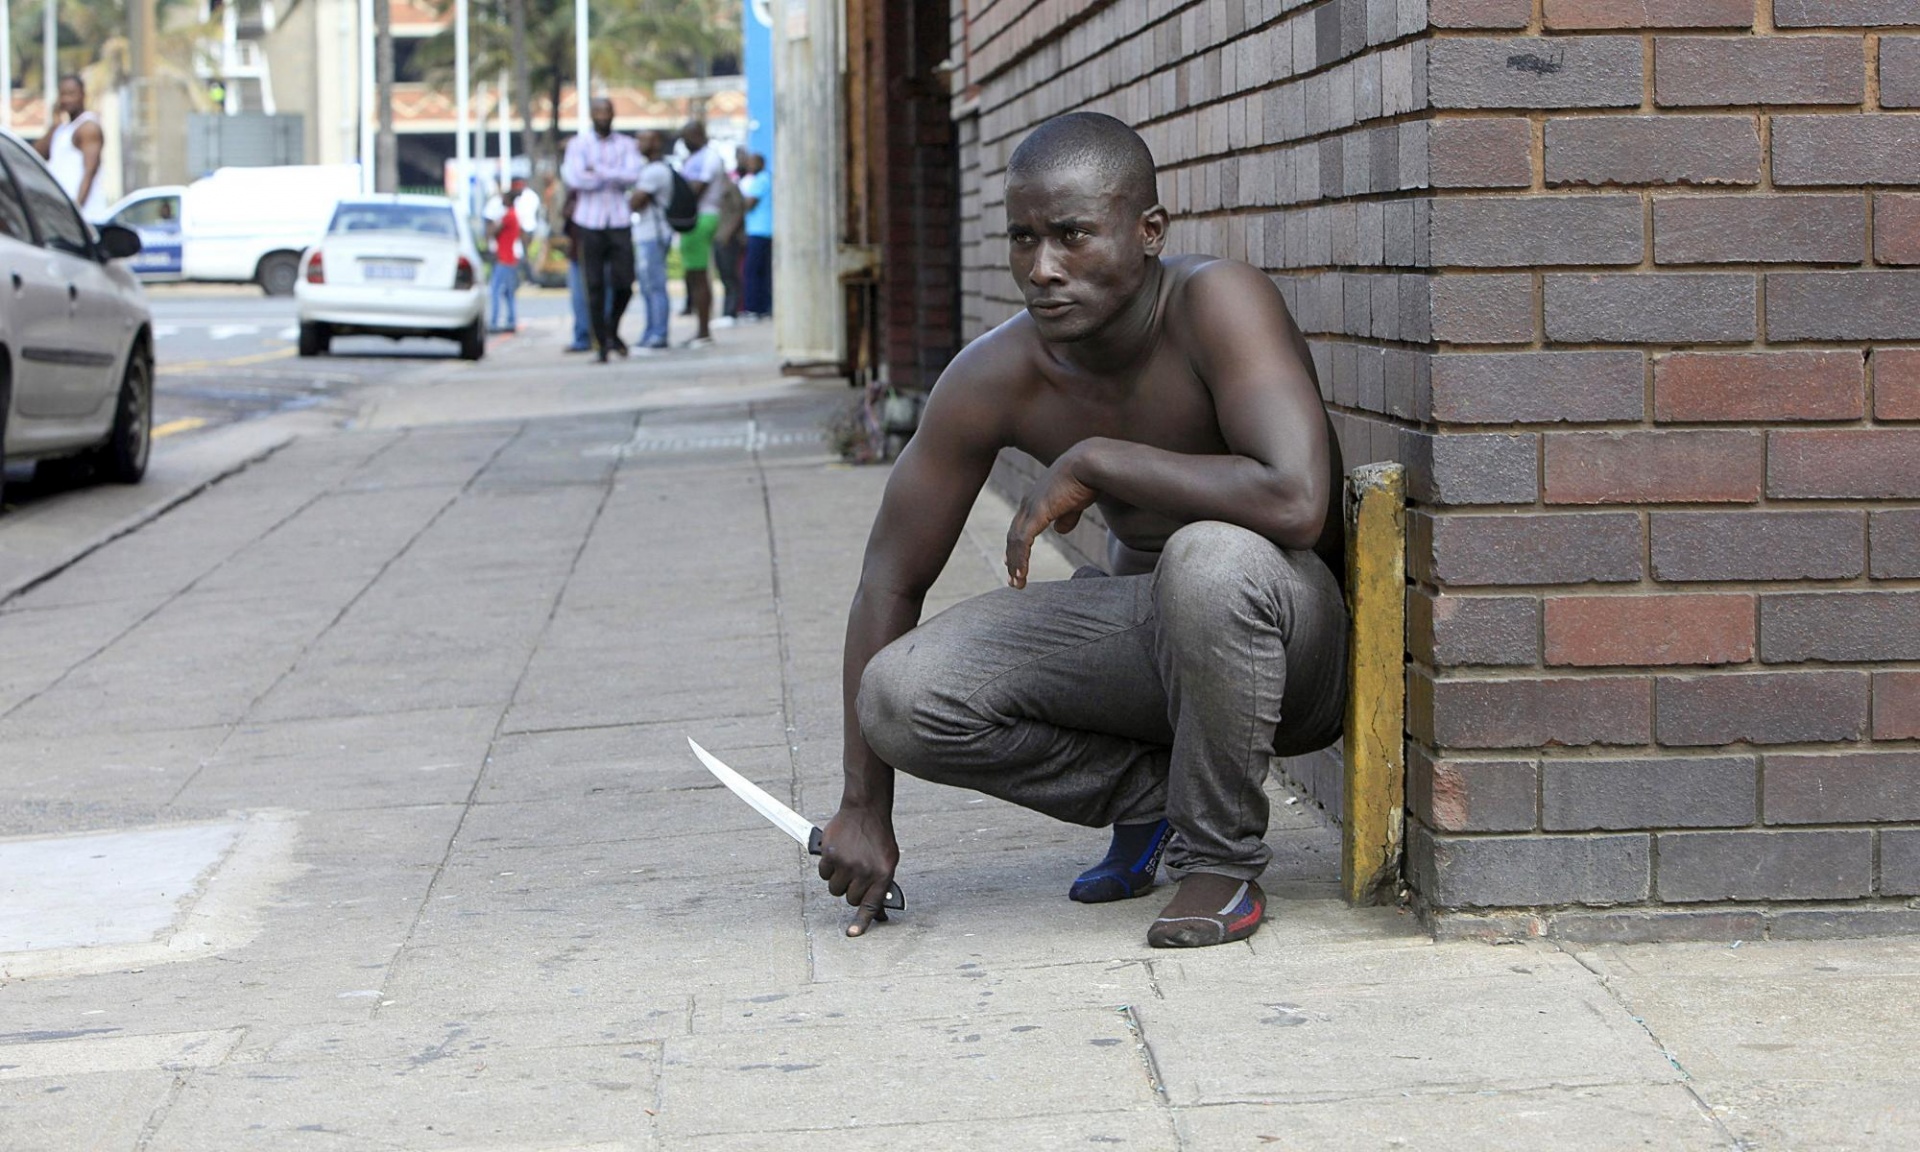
0, 132, 154, 510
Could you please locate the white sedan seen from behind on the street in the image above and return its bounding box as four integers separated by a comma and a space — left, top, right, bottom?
294, 196, 486, 359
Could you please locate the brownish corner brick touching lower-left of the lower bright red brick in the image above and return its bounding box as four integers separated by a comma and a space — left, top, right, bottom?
1407, 674, 1653, 749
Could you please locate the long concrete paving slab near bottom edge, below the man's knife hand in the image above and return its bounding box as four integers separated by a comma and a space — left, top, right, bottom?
660, 1008, 1154, 1142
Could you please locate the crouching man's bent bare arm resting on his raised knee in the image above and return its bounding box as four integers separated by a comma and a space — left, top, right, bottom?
1006, 261, 1329, 588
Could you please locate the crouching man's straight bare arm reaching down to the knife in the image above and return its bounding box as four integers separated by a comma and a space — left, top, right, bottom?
820, 348, 1004, 935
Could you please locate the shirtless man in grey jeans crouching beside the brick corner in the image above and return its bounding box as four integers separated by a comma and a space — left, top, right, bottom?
820, 113, 1346, 947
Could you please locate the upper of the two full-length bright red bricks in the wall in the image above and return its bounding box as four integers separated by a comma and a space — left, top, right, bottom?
1653, 351, 1866, 422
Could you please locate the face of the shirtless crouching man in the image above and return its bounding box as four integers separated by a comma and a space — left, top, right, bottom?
1006, 169, 1164, 344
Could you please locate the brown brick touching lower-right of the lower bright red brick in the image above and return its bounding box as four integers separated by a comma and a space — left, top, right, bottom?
1655, 672, 1868, 747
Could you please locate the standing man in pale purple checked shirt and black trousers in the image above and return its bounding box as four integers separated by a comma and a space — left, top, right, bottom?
561, 96, 641, 363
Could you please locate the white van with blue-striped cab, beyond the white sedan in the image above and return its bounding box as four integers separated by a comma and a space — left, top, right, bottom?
108, 163, 359, 296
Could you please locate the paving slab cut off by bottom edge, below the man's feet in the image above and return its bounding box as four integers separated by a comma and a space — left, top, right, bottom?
1175, 1085, 1736, 1152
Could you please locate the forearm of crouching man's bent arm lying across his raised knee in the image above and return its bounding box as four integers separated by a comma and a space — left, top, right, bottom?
1062, 436, 1327, 547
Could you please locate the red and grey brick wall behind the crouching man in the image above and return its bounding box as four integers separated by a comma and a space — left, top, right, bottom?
954, 0, 1920, 939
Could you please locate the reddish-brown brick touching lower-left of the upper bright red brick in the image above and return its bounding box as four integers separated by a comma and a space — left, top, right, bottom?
1546, 430, 1764, 503
